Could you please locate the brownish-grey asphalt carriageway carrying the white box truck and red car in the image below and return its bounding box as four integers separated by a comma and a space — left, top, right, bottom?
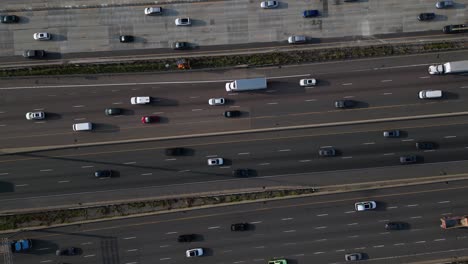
0, 52, 468, 149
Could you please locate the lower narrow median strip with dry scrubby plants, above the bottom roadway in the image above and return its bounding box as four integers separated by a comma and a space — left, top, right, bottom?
0, 173, 468, 233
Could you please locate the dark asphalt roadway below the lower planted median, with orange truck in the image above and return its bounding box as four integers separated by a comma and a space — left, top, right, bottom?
8, 181, 468, 264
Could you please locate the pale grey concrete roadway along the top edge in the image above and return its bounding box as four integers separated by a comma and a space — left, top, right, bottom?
0, 0, 468, 57
